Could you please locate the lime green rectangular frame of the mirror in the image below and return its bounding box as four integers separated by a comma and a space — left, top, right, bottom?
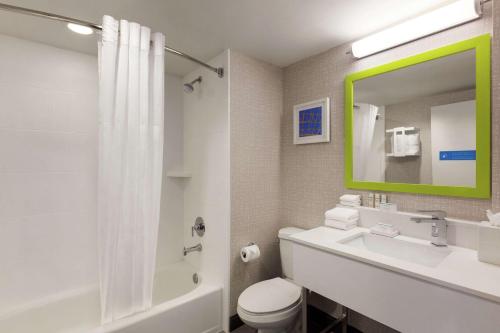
344, 34, 491, 199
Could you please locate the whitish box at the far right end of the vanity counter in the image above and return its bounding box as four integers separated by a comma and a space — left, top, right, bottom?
477, 222, 500, 265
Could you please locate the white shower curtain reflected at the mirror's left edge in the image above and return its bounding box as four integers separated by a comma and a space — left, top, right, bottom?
353, 103, 378, 181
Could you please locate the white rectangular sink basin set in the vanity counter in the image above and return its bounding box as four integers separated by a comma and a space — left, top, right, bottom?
338, 233, 451, 267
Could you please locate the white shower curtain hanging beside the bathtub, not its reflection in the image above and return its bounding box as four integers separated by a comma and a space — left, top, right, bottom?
98, 16, 165, 323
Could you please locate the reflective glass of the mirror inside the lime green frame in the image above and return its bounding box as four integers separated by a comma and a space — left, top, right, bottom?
353, 50, 476, 187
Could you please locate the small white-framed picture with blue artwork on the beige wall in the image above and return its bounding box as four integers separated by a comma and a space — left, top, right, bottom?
293, 97, 330, 145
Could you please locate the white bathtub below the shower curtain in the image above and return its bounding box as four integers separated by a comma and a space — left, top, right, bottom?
0, 262, 222, 333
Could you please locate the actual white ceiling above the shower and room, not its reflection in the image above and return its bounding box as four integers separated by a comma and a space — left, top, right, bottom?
0, 0, 450, 75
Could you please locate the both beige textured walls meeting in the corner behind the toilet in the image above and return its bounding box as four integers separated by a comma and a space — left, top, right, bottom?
230, 0, 500, 326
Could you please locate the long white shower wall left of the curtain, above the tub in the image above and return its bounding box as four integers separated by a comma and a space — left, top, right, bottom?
0, 36, 97, 313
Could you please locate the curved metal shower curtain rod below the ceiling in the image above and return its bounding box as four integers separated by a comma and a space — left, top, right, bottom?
0, 3, 224, 77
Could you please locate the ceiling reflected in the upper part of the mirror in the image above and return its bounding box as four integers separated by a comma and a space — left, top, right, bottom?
354, 50, 476, 105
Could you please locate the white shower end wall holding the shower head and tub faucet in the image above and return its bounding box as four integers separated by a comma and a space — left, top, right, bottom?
184, 51, 230, 332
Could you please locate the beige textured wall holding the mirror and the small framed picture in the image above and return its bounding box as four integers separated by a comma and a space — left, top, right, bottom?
280, 0, 500, 228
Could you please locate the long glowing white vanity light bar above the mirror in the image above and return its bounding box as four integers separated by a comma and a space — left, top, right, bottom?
352, 0, 482, 58
